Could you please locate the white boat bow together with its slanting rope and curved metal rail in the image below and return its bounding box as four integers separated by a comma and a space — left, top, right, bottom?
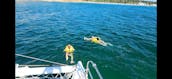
15, 54, 103, 79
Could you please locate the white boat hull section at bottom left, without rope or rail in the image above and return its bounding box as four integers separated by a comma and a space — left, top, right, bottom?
15, 61, 88, 79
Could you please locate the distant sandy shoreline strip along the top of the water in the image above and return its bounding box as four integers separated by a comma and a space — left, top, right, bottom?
16, 0, 157, 7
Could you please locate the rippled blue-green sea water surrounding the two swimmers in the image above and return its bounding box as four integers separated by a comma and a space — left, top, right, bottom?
15, 2, 157, 79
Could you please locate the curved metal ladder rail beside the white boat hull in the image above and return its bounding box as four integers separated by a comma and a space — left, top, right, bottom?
86, 61, 103, 79
